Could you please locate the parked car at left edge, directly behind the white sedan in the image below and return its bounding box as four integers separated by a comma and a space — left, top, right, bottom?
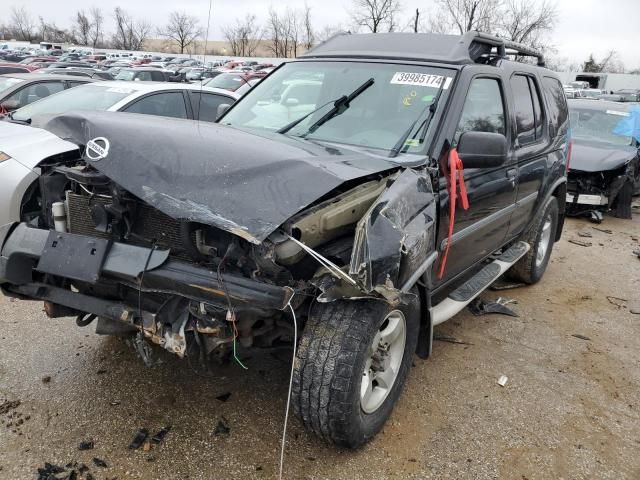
0, 73, 93, 117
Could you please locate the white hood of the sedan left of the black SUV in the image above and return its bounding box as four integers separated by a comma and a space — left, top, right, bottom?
0, 121, 78, 169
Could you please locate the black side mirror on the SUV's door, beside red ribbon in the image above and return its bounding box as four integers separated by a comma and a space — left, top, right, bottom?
457, 132, 508, 168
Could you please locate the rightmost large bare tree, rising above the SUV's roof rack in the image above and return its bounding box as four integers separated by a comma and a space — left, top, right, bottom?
498, 0, 558, 49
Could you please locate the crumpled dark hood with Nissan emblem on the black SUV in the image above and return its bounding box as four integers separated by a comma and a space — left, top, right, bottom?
43, 112, 397, 243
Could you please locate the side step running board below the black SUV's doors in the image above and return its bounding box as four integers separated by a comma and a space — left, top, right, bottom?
431, 242, 531, 326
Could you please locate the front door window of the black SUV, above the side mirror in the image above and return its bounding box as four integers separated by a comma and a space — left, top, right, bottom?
455, 78, 505, 143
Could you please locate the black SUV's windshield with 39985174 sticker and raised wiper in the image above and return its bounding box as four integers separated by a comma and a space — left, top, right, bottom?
222, 62, 455, 153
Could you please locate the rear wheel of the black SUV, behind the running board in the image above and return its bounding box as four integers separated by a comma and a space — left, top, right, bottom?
508, 196, 558, 285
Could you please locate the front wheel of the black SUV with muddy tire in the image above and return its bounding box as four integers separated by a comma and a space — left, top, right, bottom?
292, 296, 419, 448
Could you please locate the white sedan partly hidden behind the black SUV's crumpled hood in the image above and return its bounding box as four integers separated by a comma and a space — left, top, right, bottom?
0, 82, 240, 226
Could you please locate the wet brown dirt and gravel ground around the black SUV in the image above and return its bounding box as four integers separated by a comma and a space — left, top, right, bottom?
0, 215, 640, 480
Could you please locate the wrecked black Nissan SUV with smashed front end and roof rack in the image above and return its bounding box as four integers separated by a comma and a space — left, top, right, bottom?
0, 32, 570, 447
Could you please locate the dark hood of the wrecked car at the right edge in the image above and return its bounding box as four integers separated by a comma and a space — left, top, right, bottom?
570, 139, 638, 172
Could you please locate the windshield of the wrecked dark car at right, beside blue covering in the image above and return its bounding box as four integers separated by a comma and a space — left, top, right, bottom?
569, 108, 631, 145
